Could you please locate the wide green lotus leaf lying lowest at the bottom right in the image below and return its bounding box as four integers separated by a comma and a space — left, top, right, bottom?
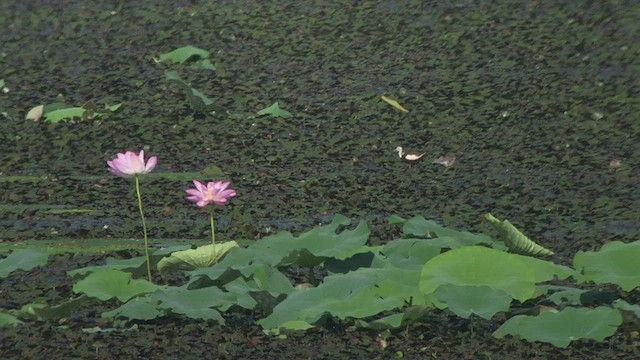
493, 306, 622, 348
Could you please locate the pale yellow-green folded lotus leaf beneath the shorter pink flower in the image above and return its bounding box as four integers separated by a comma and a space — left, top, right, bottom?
158, 241, 238, 273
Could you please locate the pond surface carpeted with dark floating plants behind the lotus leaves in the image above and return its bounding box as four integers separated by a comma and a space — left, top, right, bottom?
0, 0, 640, 358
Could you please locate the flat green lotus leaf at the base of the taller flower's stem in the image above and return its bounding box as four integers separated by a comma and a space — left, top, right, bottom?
73, 269, 162, 302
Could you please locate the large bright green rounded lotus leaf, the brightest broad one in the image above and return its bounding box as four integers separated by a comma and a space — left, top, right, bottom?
420, 246, 536, 302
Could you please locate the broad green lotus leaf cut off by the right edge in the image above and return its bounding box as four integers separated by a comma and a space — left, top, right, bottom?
573, 241, 640, 291
